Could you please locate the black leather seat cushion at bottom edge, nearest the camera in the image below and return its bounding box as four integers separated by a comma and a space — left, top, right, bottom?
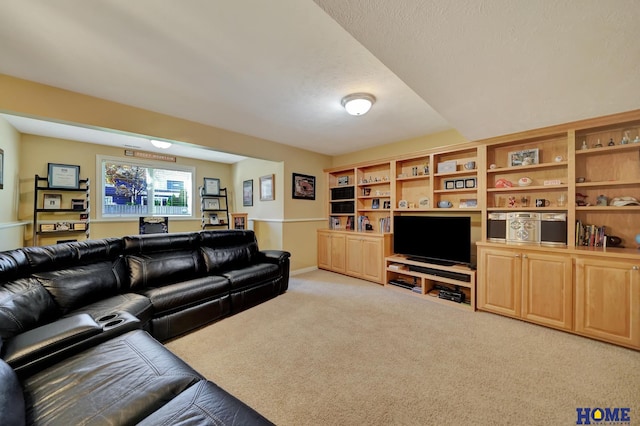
139, 380, 273, 426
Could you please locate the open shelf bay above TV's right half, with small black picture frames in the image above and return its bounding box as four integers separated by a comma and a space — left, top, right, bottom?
432, 147, 481, 210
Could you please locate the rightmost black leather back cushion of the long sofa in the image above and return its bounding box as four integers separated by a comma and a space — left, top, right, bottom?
200, 230, 259, 273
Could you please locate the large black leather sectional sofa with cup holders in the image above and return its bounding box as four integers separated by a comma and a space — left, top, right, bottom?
0, 230, 290, 425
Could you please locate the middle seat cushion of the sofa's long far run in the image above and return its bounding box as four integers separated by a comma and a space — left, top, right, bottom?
141, 276, 231, 316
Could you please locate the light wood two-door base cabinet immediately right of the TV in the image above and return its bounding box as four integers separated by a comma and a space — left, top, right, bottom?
478, 247, 573, 330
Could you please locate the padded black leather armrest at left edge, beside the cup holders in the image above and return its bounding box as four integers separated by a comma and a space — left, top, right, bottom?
3, 314, 102, 371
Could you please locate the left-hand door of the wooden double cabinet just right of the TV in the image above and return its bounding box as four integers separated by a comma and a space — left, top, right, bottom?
477, 248, 522, 317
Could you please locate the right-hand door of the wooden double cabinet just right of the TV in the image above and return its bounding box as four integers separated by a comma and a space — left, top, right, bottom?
522, 252, 573, 330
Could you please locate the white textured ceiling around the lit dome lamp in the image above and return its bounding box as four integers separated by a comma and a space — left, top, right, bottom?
0, 0, 640, 155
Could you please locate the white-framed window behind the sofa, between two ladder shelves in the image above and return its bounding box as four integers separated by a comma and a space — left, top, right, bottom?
98, 157, 195, 219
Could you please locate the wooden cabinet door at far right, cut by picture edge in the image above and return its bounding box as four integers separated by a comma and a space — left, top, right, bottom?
575, 258, 640, 348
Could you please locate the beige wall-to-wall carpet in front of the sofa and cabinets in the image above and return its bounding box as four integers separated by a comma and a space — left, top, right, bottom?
167, 271, 640, 426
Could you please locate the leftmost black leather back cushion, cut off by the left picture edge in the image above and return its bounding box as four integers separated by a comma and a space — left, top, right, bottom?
0, 278, 60, 339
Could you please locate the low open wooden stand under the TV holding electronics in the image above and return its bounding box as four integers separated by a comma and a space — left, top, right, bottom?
385, 255, 476, 311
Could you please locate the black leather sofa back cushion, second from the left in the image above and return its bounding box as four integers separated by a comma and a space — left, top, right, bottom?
34, 257, 128, 313
